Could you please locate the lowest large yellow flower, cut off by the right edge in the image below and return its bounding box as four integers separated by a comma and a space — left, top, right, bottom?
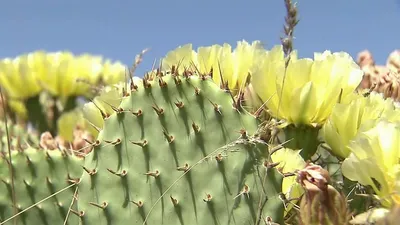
342, 119, 400, 207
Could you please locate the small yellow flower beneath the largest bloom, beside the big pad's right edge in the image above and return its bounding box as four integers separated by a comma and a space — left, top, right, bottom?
271, 148, 306, 213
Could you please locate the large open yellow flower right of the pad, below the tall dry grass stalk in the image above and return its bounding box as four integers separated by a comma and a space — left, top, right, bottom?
252, 46, 363, 126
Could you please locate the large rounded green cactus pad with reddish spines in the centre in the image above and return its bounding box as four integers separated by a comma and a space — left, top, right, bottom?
74, 75, 283, 225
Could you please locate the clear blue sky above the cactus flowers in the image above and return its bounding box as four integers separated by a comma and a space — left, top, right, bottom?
0, 0, 400, 75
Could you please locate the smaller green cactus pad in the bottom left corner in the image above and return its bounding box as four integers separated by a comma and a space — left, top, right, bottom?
0, 148, 83, 225
